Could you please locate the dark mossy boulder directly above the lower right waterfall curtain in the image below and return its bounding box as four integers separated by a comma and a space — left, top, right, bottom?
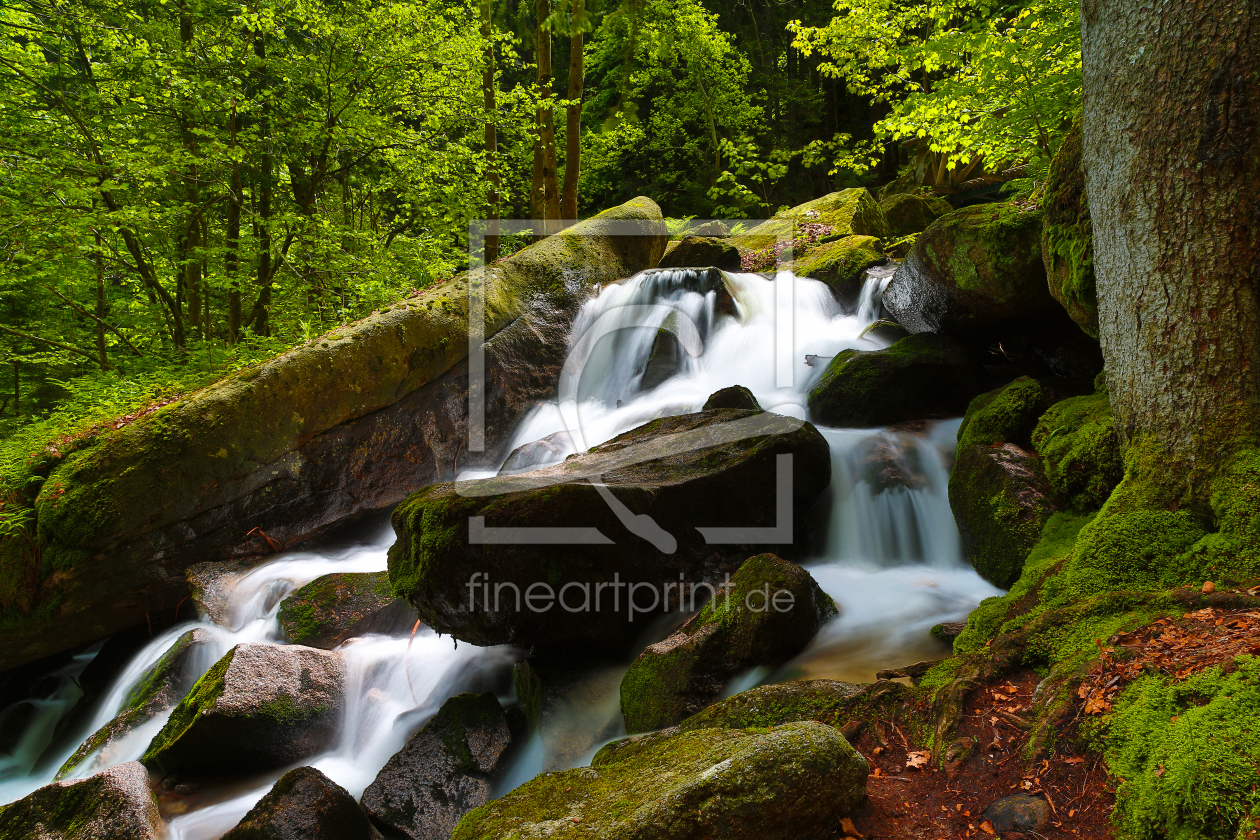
809, 334, 988, 427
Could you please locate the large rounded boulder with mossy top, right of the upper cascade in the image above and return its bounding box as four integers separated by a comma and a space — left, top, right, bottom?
883, 204, 1060, 343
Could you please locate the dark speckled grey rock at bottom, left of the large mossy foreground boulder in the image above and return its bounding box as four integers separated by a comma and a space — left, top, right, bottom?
363, 693, 512, 840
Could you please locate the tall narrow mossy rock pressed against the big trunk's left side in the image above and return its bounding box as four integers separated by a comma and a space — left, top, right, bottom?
1041, 117, 1099, 338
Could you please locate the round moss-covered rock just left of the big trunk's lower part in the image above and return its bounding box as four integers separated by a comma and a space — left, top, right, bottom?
1032, 392, 1124, 513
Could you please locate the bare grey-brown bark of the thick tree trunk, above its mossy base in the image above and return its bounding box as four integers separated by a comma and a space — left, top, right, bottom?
1081, 0, 1260, 490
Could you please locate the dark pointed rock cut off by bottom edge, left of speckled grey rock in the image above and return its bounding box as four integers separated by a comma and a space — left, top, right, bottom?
222, 767, 382, 840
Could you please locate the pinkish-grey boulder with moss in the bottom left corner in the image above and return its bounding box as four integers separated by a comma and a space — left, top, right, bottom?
0, 762, 166, 840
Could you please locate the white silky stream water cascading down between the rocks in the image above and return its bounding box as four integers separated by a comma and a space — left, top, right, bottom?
0, 264, 998, 840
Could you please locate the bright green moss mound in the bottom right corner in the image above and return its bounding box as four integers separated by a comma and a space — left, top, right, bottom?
1091, 656, 1260, 840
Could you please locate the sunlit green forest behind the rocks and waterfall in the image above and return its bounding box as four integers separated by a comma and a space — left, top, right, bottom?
0, 0, 1081, 498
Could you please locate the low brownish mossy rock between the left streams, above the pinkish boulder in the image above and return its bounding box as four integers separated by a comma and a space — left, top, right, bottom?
277, 572, 416, 650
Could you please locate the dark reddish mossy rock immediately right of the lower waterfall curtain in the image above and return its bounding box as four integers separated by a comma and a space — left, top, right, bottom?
949, 443, 1056, 589
